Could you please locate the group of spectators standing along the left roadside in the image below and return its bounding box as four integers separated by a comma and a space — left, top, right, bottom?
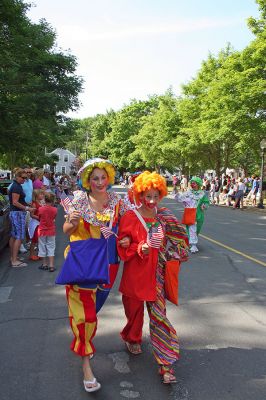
7, 166, 77, 272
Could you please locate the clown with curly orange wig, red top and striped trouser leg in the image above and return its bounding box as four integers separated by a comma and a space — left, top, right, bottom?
117, 171, 187, 384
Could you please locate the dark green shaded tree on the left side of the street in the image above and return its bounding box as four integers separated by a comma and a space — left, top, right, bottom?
0, 0, 82, 168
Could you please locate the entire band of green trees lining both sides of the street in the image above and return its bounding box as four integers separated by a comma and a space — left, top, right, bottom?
0, 0, 266, 174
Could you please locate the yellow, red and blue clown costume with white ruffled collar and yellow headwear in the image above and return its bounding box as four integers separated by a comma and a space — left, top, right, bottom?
65, 158, 132, 356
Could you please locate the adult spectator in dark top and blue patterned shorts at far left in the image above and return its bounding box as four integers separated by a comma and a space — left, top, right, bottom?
8, 168, 34, 268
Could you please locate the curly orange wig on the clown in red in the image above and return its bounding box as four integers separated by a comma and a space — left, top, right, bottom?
133, 171, 168, 200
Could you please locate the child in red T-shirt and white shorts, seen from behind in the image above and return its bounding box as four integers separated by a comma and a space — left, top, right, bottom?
38, 192, 57, 272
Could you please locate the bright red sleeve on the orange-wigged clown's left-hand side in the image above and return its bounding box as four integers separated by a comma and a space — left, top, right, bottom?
117, 211, 147, 261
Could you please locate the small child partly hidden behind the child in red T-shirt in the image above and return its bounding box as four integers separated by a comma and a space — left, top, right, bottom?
28, 189, 45, 261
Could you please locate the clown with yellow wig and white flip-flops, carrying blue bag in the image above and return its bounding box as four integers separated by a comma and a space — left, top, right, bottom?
60, 158, 129, 392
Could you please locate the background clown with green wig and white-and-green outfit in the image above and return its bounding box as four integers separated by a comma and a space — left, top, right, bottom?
175, 176, 210, 253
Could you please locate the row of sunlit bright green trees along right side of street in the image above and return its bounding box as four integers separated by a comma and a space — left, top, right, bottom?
66, 0, 266, 174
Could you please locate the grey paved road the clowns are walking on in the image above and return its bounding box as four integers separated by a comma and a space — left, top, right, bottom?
0, 191, 266, 400
